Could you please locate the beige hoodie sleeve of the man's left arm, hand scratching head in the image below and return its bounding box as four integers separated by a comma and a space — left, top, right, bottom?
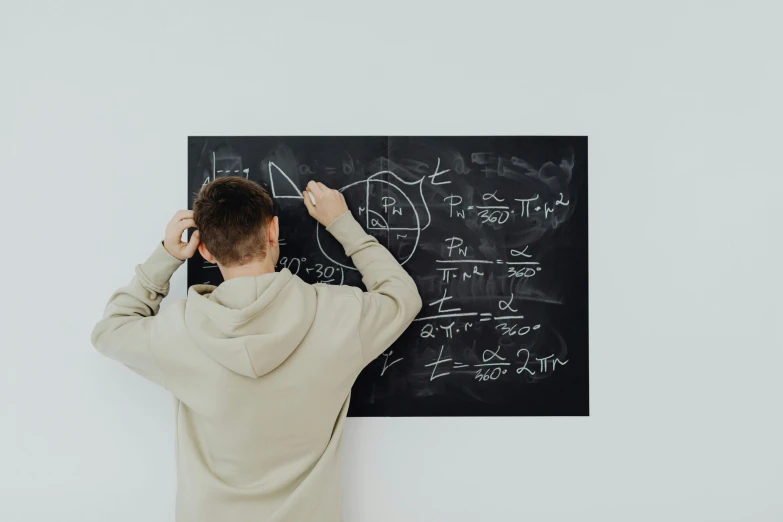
92, 242, 183, 387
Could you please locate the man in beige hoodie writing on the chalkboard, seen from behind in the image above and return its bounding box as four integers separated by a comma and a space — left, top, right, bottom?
92, 177, 421, 522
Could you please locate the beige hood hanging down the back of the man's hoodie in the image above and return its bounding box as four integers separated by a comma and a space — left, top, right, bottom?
185, 268, 316, 378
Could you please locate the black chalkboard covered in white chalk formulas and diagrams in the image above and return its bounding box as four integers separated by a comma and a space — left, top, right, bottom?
188, 136, 589, 416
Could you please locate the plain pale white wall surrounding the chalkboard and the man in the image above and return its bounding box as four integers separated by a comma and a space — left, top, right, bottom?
0, 0, 783, 522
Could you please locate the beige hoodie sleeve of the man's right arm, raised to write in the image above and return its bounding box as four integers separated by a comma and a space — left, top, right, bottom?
326, 211, 422, 365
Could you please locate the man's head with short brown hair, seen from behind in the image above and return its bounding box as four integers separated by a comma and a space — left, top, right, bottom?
193, 176, 275, 266
